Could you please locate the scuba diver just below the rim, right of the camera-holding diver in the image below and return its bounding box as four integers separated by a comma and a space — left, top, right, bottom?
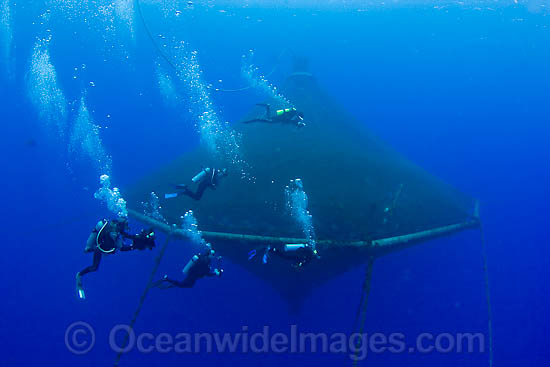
151, 247, 223, 289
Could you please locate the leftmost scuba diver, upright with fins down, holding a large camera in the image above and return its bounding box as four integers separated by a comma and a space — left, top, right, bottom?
76, 218, 155, 299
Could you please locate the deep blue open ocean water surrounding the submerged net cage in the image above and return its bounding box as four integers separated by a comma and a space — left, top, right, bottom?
0, 0, 550, 366
